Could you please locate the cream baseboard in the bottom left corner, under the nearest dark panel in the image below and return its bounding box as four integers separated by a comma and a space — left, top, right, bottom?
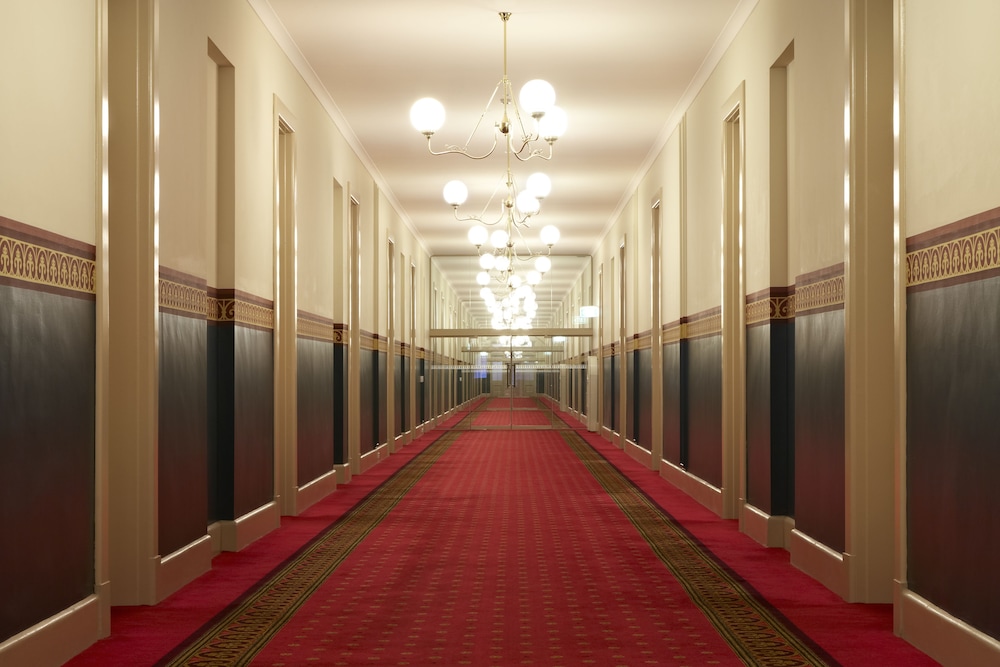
0, 595, 101, 667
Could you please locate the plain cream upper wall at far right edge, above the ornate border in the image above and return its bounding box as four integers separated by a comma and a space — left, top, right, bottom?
902, 0, 1000, 236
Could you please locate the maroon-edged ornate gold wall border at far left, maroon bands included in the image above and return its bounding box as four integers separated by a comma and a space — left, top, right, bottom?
0, 217, 97, 300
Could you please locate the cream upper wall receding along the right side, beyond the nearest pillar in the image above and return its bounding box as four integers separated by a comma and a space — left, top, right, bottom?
595, 0, 848, 326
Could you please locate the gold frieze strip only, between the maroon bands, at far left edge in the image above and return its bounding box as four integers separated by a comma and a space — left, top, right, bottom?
0, 235, 97, 294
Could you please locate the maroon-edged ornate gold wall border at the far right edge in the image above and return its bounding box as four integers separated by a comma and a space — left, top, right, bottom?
906, 208, 1000, 291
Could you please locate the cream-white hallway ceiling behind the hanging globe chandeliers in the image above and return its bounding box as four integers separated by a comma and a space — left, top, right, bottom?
250, 0, 757, 326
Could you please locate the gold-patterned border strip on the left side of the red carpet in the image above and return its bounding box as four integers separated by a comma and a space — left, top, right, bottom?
160, 431, 461, 667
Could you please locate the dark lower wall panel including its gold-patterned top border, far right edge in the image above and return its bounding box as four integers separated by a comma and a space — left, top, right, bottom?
906, 215, 1000, 637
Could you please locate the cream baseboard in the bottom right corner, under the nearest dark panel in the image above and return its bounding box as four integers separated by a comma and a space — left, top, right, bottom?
895, 582, 1000, 665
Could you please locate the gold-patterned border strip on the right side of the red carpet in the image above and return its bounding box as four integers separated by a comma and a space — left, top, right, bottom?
562, 432, 828, 667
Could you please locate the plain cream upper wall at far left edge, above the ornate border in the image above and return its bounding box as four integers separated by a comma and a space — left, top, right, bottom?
0, 0, 101, 245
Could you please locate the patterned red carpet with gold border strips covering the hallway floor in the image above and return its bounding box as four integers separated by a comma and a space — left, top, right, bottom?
72, 404, 934, 667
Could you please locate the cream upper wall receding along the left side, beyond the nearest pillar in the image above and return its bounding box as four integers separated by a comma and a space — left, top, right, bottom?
159, 0, 425, 324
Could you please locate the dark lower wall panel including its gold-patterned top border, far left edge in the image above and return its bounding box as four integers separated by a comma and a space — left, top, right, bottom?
0, 218, 96, 642
